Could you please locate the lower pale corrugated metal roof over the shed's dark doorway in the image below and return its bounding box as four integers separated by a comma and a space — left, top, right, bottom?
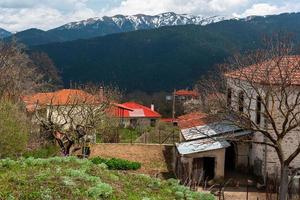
176, 138, 230, 155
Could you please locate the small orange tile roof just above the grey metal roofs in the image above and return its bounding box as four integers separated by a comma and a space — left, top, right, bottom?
178, 112, 212, 129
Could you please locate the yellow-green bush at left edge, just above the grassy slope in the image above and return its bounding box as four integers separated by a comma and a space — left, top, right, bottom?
0, 100, 30, 157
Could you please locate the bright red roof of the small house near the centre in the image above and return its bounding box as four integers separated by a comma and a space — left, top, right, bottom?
122, 102, 161, 118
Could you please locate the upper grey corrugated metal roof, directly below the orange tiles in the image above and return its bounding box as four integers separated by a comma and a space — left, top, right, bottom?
181, 122, 241, 140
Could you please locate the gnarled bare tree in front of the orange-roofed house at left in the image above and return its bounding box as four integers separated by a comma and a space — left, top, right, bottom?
34, 85, 122, 156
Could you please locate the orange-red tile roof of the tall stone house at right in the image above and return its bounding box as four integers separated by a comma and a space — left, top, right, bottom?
225, 56, 300, 85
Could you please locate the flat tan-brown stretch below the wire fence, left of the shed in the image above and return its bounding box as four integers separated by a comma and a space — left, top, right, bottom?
91, 143, 175, 176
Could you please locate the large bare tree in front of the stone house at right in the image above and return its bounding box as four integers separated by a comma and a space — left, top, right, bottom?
199, 36, 300, 200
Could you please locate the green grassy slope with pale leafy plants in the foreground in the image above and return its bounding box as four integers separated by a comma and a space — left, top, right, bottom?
0, 157, 214, 200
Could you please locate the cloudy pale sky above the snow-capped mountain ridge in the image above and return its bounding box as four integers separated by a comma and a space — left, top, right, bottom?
0, 0, 300, 32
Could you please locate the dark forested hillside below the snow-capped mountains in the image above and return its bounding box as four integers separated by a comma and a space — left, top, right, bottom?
32, 13, 300, 92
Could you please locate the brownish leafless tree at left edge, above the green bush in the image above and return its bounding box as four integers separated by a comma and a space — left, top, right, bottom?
0, 41, 43, 101
